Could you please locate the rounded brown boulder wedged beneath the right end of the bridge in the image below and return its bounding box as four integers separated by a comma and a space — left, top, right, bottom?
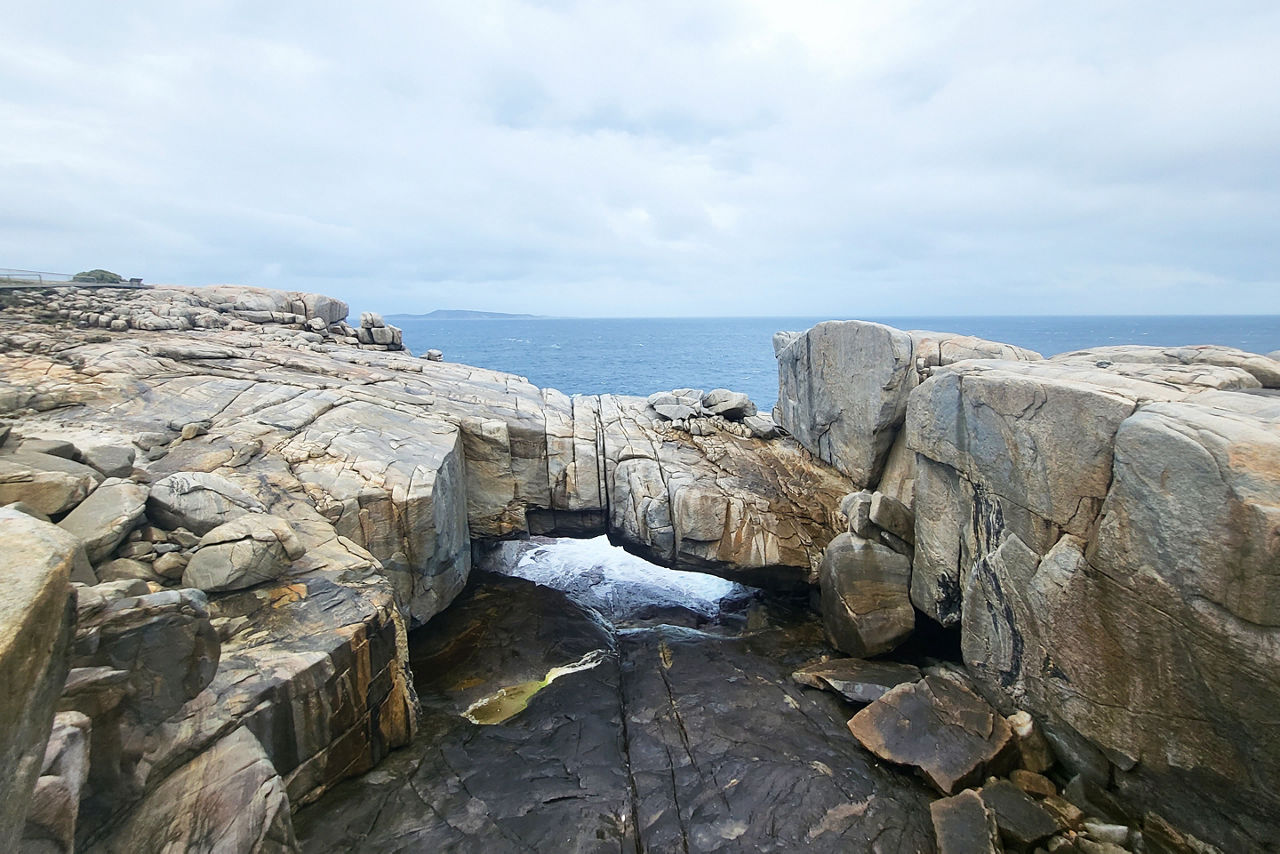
819, 534, 915, 657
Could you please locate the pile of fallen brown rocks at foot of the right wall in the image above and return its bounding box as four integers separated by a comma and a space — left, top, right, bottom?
792, 658, 1216, 854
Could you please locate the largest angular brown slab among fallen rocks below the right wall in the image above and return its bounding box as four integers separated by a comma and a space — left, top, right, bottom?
849, 676, 1012, 794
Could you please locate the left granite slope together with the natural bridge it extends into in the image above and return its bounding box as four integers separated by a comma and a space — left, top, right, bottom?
0, 287, 850, 850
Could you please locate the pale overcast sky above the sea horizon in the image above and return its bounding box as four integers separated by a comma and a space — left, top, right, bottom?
0, 0, 1280, 318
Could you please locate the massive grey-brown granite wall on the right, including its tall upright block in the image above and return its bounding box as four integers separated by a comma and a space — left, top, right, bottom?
778, 324, 1280, 850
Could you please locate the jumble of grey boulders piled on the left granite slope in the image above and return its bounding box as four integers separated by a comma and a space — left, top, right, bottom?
0, 424, 306, 853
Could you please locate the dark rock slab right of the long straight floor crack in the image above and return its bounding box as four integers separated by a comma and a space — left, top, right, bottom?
620, 627, 933, 851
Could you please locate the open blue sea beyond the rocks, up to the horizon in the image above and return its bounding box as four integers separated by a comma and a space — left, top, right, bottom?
388, 315, 1280, 410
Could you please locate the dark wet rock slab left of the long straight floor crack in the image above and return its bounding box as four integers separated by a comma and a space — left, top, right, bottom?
297, 572, 635, 853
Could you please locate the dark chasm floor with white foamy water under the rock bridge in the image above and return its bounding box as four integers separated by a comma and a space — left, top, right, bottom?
294, 538, 934, 854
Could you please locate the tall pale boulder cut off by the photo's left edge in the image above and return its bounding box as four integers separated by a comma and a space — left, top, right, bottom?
0, 508, 79, 851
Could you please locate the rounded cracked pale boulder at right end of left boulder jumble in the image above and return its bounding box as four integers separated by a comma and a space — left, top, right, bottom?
182, 513, 306, 593
